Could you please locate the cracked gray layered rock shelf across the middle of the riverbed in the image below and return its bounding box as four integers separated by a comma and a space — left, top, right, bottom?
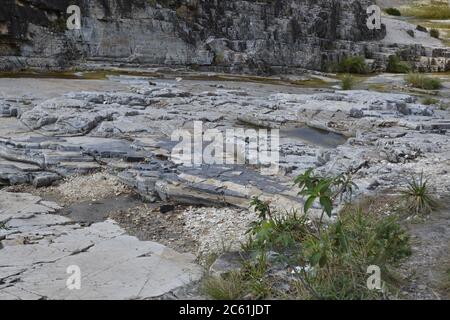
0, 81, 450, 218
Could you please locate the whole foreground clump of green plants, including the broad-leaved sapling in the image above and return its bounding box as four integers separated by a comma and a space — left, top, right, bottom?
207, 169, 411, 299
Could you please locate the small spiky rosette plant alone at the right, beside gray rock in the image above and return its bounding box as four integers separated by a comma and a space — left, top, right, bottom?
401, 173, 438, 215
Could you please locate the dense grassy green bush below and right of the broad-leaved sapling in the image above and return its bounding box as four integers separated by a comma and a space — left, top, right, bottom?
297, 210, 411, 299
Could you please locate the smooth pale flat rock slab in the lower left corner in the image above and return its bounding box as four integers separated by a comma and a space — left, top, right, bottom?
0, 191, 202, 300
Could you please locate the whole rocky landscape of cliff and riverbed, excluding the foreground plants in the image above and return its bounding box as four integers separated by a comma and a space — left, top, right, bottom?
0, 0, 450, 300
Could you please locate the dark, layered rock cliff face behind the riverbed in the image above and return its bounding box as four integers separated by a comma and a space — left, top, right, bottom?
0, 0, 448, 72
